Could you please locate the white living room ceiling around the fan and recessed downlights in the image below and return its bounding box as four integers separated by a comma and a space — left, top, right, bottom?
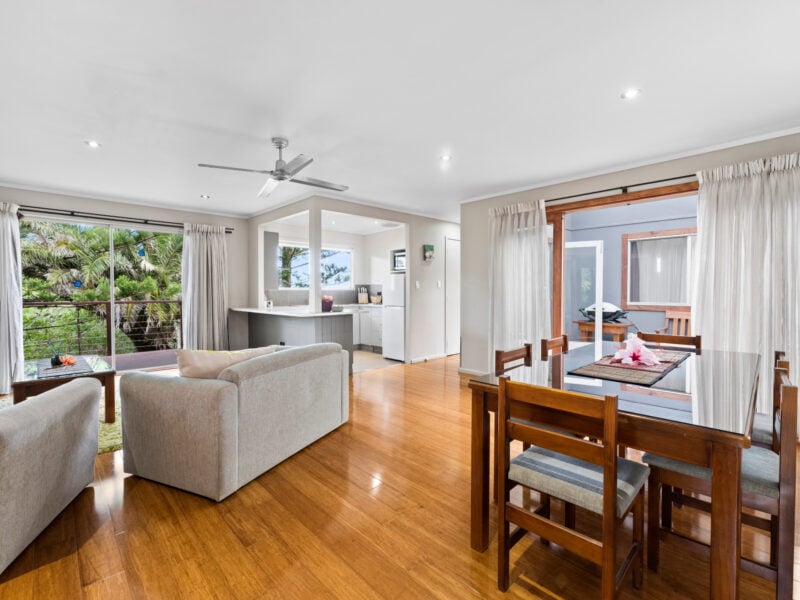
0, 0, 800, 220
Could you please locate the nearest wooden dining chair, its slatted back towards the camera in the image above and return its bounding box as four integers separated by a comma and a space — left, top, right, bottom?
495, 377, 648, 599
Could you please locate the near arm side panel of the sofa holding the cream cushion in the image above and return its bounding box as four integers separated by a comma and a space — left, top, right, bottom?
120, 372, 238, 500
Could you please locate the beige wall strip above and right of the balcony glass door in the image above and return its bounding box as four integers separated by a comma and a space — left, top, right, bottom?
0, 187, 250, 348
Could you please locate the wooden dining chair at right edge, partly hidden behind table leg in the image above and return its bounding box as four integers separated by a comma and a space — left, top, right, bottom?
642, 369, 797, 600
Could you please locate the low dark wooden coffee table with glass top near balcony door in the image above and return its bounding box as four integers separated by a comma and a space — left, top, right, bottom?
11, 355, 116, 423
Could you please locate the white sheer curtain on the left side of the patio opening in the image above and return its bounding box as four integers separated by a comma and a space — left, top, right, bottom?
489, 200, 551, 360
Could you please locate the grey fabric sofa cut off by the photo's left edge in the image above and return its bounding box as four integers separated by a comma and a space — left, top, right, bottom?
0, 378, 100, 573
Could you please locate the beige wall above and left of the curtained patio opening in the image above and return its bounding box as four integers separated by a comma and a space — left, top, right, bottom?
461, 134, 800, 373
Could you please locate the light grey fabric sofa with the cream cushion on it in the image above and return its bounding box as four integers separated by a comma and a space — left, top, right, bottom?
120, 344, 350, 501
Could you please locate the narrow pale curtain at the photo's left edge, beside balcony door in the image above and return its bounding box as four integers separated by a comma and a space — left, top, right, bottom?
0, 202, 24, 394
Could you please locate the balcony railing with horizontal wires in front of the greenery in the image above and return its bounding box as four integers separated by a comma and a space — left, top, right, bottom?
22, 300, 183, 369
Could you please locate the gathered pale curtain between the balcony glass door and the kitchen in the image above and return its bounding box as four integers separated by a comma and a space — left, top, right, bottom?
182, 223, 228, 350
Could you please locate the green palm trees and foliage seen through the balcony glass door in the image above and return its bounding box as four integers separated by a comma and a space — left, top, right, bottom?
20, 220, 183, 359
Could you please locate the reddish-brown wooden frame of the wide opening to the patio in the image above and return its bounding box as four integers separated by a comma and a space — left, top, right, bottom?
545, 181, 700, 337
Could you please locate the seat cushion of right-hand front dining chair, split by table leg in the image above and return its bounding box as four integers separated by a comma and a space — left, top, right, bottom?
642, 446, 780, 499
